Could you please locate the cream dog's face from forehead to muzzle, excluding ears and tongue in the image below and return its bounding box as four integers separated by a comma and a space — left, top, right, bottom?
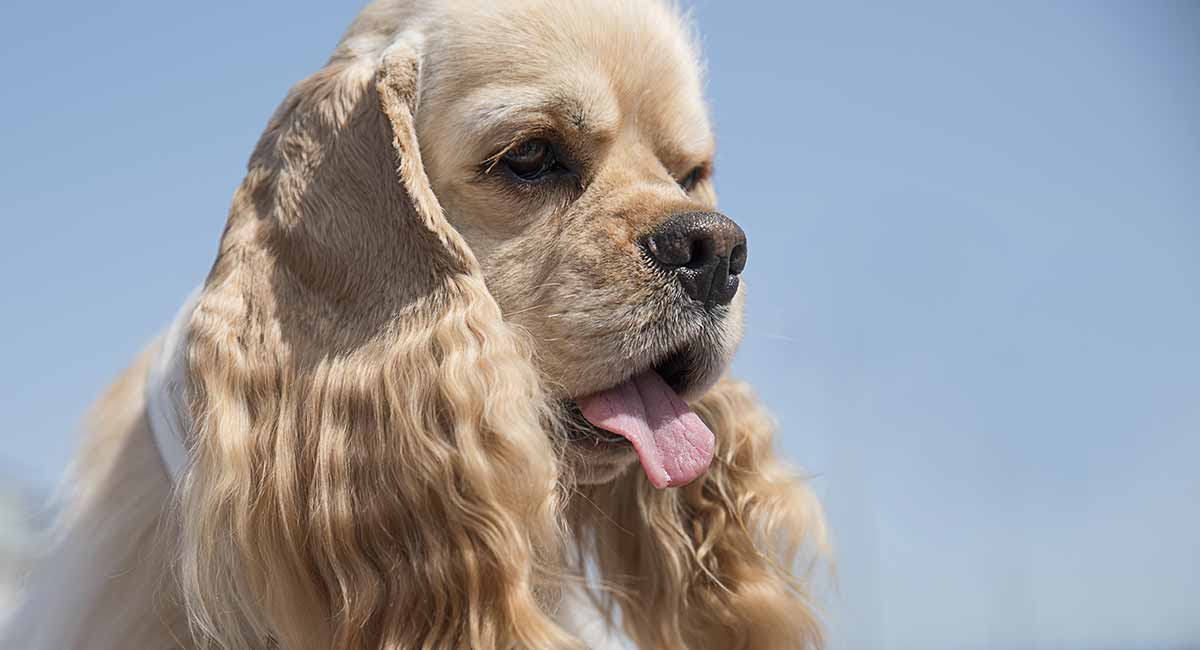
418, 0, 746, 479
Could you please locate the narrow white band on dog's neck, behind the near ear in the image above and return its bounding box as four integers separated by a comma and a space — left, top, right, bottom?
145, 289, 200, 482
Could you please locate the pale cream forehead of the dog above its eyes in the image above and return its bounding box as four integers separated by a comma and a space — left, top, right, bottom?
428, 0, 713, 156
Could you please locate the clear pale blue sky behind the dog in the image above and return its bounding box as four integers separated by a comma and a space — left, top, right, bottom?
0, 0, 1200, 649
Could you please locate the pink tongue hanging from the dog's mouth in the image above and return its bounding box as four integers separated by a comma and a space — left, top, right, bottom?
577, 371, 713, 488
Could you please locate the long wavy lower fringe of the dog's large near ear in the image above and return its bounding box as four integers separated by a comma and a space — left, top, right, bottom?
182, 276, 570, 650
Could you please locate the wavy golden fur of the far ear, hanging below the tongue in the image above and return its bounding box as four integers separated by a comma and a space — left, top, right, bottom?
571, 379, 824, 649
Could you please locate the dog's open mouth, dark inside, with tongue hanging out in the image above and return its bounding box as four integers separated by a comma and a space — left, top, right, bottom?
566, 348, 714, 488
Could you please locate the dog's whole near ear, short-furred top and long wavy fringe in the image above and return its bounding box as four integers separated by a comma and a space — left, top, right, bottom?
180, 35, 571, 650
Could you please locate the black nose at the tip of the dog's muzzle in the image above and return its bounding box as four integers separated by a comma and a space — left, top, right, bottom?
641, 212, 746, 307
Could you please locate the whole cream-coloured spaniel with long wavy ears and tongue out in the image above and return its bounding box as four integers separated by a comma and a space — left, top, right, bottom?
6, 0, 823, 650
